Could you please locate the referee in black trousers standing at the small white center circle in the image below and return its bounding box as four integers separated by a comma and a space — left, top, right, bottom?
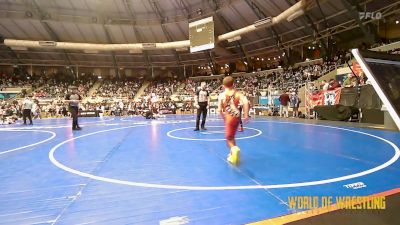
194, 82, 210, 131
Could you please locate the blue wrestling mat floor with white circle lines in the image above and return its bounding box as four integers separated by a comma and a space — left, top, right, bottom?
0, 115, 400, 225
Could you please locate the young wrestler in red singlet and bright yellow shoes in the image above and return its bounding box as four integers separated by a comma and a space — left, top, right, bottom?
218, 76, 249, 165
